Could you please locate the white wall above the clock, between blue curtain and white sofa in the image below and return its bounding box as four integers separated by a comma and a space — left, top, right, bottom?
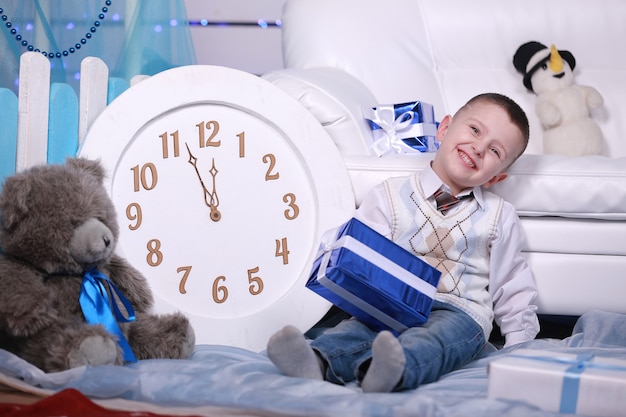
185, 0, 284, 75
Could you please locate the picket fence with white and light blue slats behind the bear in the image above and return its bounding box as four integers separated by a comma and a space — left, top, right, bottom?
0, 52, 145, 187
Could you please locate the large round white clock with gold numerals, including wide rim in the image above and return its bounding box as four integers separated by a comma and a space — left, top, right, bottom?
78, 65, 354, 351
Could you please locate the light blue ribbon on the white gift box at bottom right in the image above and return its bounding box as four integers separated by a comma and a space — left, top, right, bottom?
508, 353, 626, 414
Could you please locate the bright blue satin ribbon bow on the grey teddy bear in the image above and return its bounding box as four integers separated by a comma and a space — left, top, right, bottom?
79, 269, 137, 362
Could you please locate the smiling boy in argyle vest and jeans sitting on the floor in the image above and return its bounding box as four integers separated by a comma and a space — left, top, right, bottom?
267, 93, 539, 392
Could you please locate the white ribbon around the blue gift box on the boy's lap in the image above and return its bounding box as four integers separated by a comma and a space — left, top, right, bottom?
316, 230, 437, 332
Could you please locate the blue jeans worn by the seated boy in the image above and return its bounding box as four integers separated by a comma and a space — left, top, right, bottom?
311, 301, 486, 391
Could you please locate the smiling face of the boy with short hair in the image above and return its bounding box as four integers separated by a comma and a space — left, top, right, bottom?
432, 102, 523, 195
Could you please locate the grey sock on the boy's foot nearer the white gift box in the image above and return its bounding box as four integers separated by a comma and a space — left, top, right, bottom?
361, 331, 406, 392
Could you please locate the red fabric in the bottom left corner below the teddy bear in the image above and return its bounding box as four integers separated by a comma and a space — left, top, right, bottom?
0, 389, 200, 417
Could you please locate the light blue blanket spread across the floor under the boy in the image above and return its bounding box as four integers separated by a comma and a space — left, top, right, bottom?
0, 311, 626, 417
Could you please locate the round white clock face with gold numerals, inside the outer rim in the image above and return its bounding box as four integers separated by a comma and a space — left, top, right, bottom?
111, 104, 319, 319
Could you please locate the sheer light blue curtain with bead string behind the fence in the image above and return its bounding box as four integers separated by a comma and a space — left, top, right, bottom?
0, 0, 196, 93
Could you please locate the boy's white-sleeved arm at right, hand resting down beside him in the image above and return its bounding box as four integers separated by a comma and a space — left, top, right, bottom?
489, 202, 539, 347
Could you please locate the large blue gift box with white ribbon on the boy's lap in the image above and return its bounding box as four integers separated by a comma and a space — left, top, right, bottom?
306, 218, 441, 334
